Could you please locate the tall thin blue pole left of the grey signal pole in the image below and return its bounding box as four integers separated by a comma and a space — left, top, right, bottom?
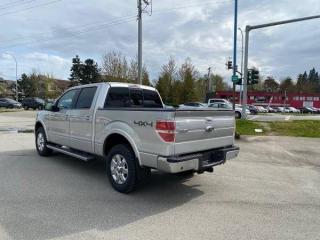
232, 0, 238, 109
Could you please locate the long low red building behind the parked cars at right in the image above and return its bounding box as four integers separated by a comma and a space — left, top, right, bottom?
215, 91, 320, 108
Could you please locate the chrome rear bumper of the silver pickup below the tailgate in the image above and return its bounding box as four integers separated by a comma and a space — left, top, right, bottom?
157, 146, 240, 173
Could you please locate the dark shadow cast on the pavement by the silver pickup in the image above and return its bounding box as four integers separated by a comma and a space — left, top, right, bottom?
0, 150, 203, 240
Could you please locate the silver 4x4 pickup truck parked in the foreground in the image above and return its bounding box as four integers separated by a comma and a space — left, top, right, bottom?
35, 82, 239, 193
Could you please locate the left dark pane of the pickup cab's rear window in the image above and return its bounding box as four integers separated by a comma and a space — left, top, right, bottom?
104, 87, 130, 108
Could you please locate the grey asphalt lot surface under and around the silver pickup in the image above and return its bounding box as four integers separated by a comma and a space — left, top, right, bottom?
0, 123, 320, 240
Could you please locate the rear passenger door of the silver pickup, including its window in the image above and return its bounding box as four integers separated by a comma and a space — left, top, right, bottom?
70, 86, 98, 152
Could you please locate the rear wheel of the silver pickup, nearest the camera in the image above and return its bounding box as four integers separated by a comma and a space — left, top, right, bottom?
106, 144, 140, 193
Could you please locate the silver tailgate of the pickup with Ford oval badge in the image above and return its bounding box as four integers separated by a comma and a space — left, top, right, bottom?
174, 110, 235, 155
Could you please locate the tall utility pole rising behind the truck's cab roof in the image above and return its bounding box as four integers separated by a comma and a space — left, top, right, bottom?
138, 0, 152, 84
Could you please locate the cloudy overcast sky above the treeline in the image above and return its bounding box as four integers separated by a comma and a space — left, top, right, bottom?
0, 0, 320, 84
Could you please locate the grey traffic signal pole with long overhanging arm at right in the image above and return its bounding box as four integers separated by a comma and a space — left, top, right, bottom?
242, 15, 320, 119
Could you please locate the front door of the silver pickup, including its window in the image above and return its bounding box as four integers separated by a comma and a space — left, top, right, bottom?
47, 89, 79, 146
